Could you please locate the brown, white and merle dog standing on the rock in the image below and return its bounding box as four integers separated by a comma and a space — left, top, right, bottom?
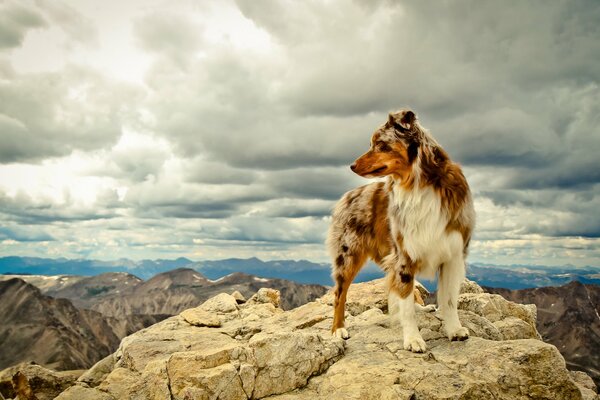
327, 110, 475, 352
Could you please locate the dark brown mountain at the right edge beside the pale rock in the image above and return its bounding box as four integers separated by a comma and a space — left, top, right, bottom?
486, 281, 600, 385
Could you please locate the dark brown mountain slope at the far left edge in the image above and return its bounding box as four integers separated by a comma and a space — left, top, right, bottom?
0, 278, 119, 369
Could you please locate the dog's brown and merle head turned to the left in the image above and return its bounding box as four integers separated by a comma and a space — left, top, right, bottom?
350, 110, 421, 180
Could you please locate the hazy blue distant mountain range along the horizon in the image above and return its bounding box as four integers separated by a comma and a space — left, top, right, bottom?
0, 257, 600, 290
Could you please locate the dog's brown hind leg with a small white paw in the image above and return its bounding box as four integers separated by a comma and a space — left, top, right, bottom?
331, 254, 367, 339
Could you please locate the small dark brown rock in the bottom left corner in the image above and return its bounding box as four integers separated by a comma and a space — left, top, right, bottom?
0, 363, 83, 400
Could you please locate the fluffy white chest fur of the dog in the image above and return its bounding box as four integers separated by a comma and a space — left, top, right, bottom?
389, 185, 462, 278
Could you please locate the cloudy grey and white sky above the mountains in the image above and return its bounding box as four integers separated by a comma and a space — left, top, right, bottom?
0, 0, 600, 266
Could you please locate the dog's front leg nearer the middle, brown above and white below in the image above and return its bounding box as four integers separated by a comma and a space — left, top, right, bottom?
386, 255, 427, 353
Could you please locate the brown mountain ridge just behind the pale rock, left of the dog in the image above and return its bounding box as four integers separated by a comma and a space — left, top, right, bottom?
48, 268, 327, 318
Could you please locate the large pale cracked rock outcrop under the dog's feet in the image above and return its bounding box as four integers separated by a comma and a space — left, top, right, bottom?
58, 280, 597, 400
